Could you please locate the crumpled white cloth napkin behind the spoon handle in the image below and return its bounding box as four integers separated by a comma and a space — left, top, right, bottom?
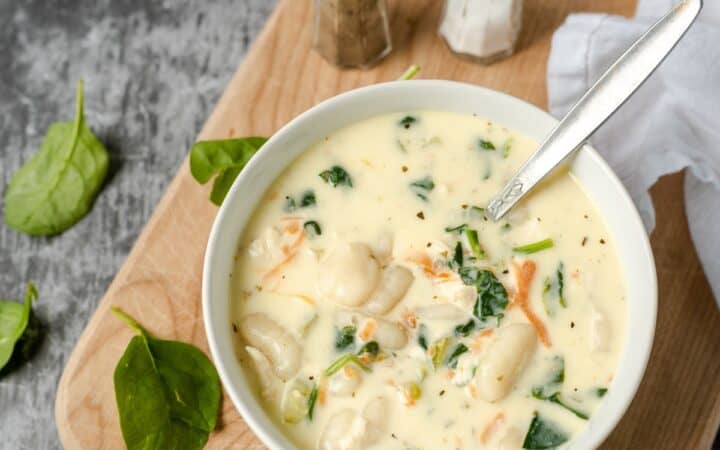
547, 0, 720, 304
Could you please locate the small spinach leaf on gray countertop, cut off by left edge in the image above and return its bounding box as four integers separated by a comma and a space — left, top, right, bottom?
0, 283, 38, 370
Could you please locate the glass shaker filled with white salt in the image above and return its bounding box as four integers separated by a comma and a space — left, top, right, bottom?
438, 0, 523, 64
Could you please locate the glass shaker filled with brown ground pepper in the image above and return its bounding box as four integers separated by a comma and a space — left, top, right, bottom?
313, 0, 392, 68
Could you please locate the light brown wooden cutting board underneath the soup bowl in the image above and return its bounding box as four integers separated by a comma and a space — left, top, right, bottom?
56, 0, 720, 450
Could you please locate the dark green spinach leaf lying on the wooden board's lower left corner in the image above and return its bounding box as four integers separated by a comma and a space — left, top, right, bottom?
112, 307, 220, 450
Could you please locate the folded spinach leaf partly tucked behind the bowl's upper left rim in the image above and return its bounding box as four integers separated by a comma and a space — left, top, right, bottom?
190, 136, 268, 206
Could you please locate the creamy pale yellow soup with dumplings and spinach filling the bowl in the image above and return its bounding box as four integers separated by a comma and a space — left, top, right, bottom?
232, 111, 626, 449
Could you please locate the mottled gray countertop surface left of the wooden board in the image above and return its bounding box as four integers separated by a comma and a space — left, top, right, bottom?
0, 0, 276, 450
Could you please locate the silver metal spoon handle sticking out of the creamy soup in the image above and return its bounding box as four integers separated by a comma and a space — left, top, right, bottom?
487, 0, 703, 220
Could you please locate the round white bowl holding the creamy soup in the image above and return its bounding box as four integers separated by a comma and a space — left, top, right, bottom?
203, 81, 657, 449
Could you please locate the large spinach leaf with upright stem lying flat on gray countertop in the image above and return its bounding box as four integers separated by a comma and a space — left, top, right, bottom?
5, 82, 109, 236
